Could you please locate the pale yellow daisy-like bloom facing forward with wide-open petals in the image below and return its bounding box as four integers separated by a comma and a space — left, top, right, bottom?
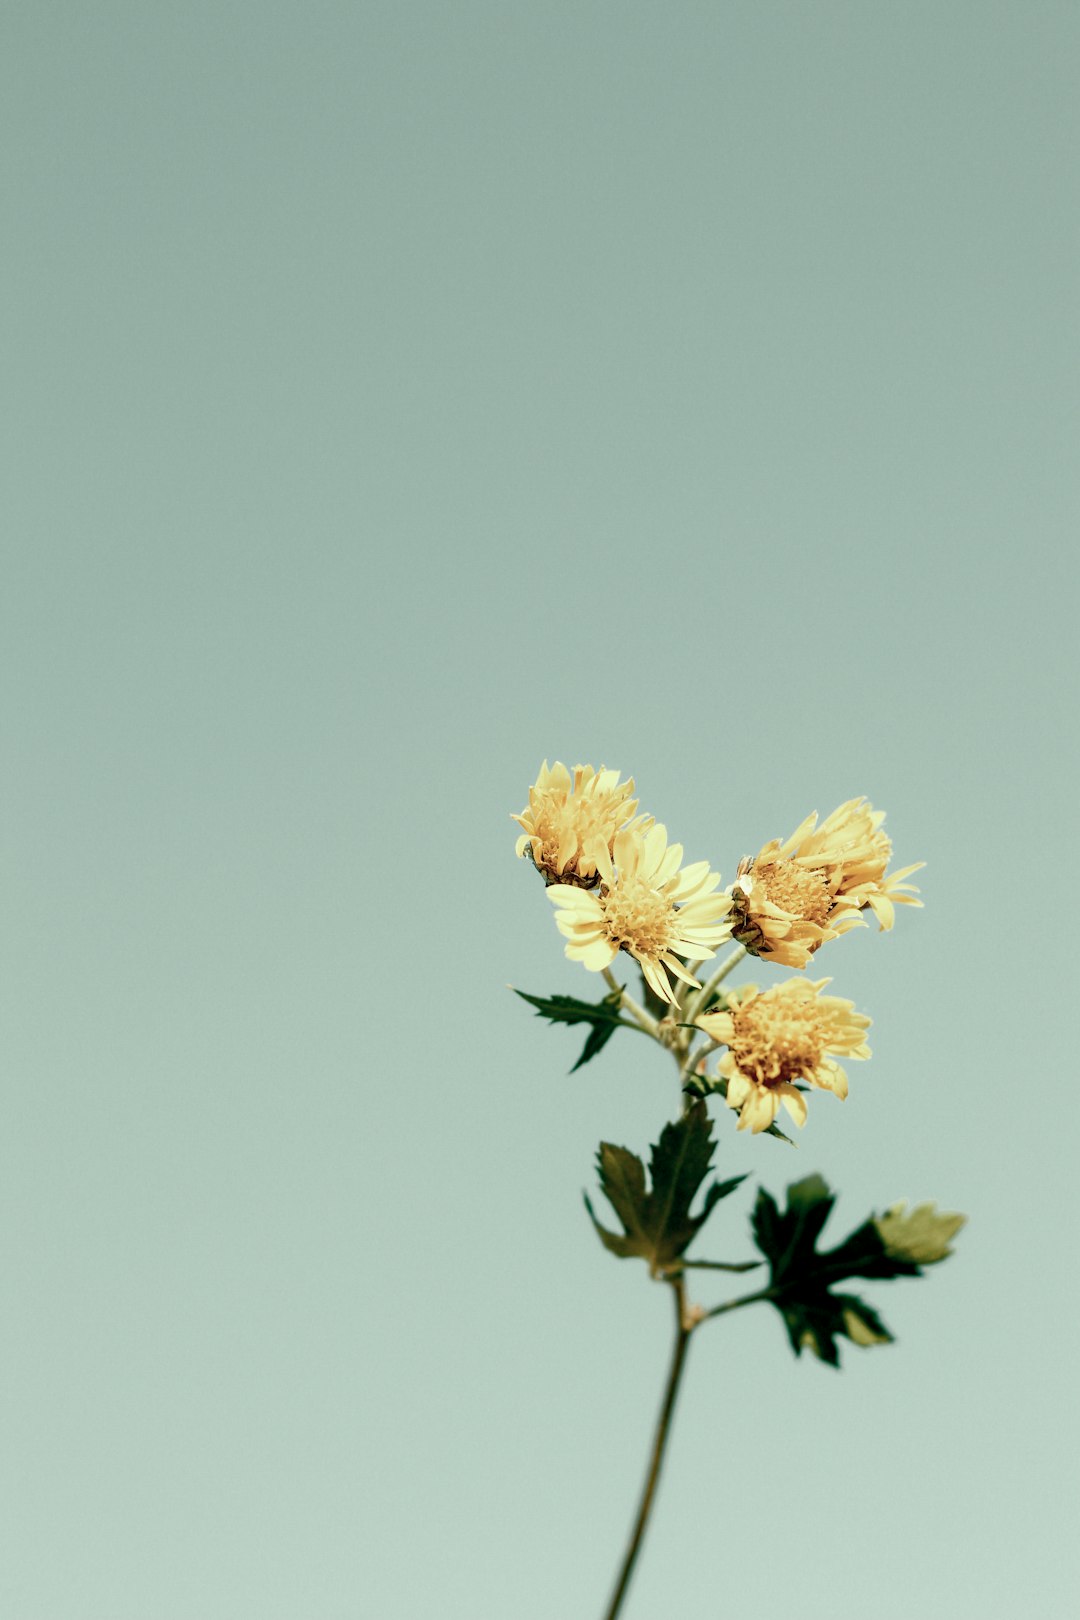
547, 825, 732, 1003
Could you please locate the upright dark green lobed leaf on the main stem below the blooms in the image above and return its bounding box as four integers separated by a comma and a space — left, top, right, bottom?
585, 1103, 746, 1277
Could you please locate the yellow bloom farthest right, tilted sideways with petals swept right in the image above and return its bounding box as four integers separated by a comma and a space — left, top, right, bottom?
732, 799, 923, 967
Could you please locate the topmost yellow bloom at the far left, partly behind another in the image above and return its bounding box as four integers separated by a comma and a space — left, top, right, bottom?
512, 760, 644, 888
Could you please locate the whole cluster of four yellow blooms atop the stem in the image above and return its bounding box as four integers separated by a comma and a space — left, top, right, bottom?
513, 761, 921, 1132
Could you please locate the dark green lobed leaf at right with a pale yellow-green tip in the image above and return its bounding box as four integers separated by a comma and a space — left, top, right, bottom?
751, 1176, 963, 1367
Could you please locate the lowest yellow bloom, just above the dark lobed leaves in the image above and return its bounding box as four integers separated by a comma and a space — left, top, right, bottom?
696, 978, 870, 1131
